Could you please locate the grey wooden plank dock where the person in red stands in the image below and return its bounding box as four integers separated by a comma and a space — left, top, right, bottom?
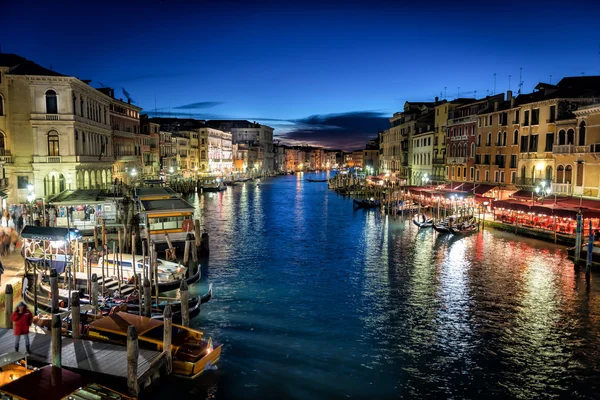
0, 329, 166, 387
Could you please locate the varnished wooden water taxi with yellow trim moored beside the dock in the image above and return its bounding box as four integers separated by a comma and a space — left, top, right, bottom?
87, 312, 222, 379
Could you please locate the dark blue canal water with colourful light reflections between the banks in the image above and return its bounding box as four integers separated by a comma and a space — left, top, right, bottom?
156, 174, 600, 399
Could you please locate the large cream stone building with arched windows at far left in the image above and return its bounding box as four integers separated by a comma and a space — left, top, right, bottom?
0, 54, 113, 208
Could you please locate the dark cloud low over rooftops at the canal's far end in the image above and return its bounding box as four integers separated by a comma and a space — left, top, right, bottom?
278, 111, 389, 150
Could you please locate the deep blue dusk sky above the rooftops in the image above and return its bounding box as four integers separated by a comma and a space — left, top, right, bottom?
0, 0, 600, 148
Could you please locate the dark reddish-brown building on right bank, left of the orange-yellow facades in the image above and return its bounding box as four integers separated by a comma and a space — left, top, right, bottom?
446, 94, 504, 182
